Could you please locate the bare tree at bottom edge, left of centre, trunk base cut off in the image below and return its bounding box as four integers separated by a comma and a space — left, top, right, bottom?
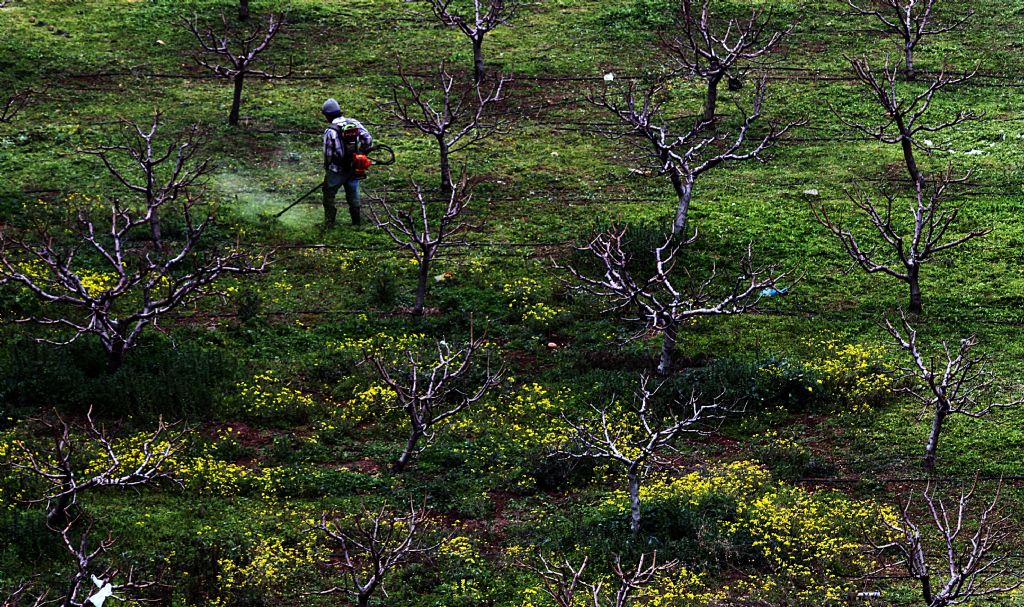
315, 504, 440, 607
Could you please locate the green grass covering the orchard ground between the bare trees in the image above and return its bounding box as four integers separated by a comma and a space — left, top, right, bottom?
0, 0, 1024, 607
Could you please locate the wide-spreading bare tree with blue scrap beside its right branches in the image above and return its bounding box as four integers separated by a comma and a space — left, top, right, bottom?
565, 227, 788, 376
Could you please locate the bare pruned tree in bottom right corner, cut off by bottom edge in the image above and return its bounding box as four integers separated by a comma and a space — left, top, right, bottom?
872, 480, 1024, 607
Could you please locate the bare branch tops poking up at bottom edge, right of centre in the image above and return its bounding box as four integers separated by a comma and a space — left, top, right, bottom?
518, 551, 679, 607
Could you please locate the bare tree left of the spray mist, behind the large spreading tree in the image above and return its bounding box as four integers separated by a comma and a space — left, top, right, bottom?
79, 110, 213, 246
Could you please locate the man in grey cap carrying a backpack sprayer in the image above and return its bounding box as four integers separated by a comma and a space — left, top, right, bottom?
323, 99, 374, 228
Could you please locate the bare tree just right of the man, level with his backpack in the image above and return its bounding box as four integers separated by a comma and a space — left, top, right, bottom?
380, 62, 512, 194
